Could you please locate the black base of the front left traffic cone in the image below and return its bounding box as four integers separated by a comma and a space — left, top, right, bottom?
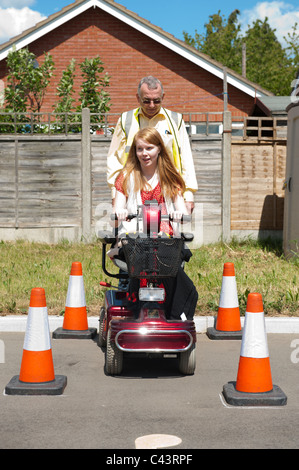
5, 375, 67, 395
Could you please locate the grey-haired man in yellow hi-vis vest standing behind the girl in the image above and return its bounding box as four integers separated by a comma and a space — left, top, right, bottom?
107, 76, 198, 213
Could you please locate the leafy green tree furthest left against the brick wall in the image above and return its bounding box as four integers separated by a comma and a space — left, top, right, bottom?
5, 47, 54, 113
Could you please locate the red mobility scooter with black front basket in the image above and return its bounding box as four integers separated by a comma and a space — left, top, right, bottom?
98, 201, 196, 375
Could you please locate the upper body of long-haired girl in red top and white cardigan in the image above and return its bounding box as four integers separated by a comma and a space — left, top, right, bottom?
114, 127, 188, 235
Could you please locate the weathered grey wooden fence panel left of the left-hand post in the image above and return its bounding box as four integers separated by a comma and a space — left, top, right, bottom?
0, 138, 81, 228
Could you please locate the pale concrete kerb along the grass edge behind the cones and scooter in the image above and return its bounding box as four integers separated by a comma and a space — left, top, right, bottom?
0, 315, 299, 334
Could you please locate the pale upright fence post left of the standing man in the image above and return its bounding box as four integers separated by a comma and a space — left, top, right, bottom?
81, 108, 91, 241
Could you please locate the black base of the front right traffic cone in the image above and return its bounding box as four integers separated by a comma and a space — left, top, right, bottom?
222, 382, 287, 406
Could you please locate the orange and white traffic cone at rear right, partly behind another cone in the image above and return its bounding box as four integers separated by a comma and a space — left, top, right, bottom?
207, 263, 242, 339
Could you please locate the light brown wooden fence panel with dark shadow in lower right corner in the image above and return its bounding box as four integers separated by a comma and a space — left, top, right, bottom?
231, 142, 286, 230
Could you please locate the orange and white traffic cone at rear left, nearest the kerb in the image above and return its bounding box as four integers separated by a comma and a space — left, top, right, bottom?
53, 262, 97, 339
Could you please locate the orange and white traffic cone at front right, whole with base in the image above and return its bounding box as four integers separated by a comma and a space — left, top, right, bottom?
223, 293, 287, 406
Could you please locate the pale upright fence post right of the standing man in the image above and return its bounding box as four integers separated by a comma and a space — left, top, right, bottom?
222, 111, 232, 241
